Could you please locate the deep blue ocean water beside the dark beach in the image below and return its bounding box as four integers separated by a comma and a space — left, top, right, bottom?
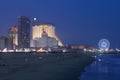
79, 54, 120, 80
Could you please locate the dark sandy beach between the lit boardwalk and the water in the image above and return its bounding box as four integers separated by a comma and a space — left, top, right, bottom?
0, 53, 95, 80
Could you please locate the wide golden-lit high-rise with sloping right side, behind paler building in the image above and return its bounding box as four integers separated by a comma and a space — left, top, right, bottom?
32, 23, 63, 46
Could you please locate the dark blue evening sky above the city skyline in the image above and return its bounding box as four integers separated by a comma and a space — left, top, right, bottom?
0, 0, 120, 48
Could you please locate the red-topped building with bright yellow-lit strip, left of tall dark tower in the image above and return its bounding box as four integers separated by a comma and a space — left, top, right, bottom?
8, 26, 18, 49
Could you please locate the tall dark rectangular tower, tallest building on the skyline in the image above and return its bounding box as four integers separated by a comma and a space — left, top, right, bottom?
18, 16, 30, 48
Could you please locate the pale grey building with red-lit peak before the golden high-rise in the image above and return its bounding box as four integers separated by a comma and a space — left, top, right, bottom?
31, 30, 58, 48
